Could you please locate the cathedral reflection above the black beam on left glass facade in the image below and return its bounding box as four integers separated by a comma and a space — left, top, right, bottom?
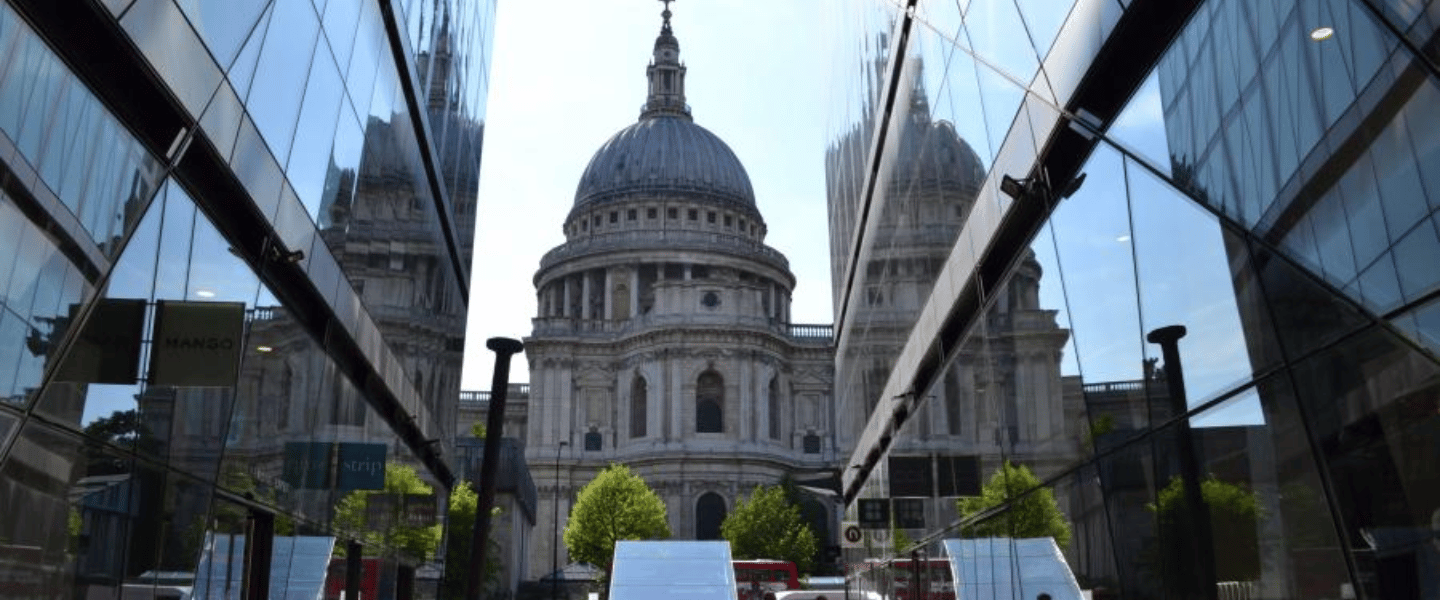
321, 24, 484, 454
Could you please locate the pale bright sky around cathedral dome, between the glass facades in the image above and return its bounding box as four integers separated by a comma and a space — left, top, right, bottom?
461, 0, 834, 390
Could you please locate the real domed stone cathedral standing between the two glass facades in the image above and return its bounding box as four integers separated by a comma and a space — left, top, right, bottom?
526, 4, 837, 577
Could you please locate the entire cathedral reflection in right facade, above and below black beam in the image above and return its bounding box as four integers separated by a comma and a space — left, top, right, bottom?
827, 59, 1080, 524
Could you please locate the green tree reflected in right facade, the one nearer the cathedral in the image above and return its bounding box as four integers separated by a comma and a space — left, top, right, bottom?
955, 460, 1070, 548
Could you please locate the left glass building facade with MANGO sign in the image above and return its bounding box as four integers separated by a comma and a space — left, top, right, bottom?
0, 0, 494, 599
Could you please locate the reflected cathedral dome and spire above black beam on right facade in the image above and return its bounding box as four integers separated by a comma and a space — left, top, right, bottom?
827, 60, 985, 446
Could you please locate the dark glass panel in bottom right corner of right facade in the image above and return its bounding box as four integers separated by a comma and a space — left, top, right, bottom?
1295, 328, 1440, 597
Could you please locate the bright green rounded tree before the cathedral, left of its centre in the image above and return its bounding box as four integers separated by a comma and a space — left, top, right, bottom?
564, 463, 670, 571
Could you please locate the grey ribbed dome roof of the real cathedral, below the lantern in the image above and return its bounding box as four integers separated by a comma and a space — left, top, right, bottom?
575, 115, 754, 207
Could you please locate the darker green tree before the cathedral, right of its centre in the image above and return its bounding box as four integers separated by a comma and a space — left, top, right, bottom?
720, 485, 819, 573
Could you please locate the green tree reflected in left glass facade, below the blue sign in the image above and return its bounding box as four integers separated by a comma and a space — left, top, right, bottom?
334, 462, 441, 561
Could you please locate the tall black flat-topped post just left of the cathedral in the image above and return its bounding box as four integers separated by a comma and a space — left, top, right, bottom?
465, 338, 526, 600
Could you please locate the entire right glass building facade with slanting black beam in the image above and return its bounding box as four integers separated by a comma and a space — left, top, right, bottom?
827, 0, 1440, 599
